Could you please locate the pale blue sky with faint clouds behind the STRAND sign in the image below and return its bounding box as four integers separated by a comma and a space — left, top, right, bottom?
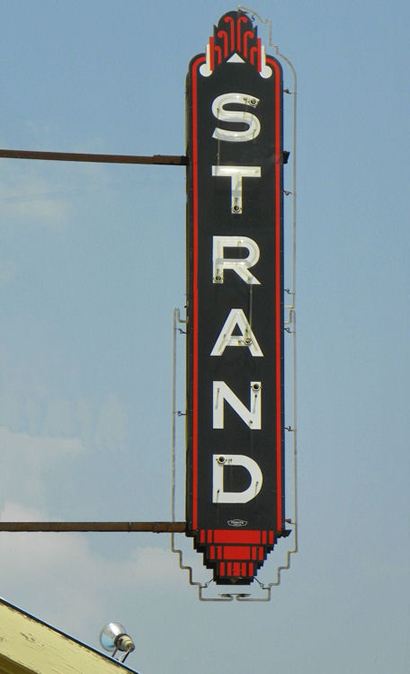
0, 0, 410, 674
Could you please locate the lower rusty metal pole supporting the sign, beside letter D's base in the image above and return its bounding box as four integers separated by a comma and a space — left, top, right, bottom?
0, 522, 186, 534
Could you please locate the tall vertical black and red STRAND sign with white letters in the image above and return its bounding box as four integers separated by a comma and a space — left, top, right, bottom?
187, 11, 288, 584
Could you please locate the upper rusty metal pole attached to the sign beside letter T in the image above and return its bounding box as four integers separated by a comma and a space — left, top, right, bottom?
0, 149, 188, 166
